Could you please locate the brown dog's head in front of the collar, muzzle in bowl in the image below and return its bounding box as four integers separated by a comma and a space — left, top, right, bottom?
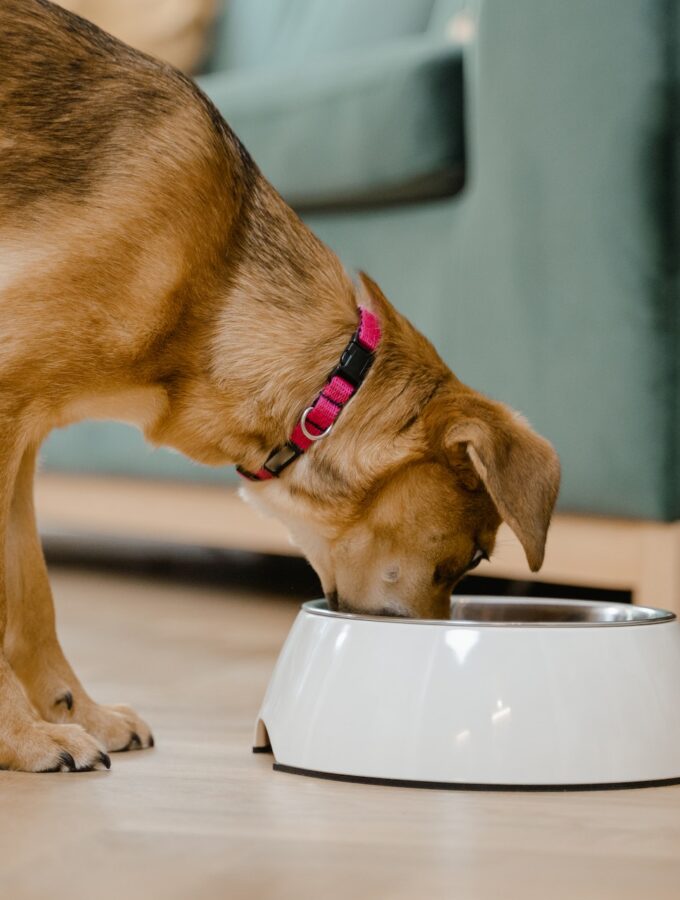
242, 282, 560, 618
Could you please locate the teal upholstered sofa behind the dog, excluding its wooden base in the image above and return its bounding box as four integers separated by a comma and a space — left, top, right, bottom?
45, 0, 680, 521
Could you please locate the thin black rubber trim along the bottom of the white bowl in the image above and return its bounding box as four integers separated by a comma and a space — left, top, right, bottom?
270, 764, 680, 793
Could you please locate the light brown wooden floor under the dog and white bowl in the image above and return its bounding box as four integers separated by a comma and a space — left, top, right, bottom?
0, 570, 680, 900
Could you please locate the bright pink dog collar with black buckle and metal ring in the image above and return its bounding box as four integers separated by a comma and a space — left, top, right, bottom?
236, 306, 381, 481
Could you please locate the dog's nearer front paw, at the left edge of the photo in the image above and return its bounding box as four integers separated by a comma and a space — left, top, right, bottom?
0, 719, 111, 772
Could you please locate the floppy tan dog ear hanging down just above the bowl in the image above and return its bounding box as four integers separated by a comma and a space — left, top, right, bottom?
444, 392, 560, 572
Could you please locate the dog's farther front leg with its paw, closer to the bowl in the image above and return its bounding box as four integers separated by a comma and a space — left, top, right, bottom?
6, 450, 153, 751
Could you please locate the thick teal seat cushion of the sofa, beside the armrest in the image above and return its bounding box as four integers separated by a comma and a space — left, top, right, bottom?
199, 35, 464, 209
